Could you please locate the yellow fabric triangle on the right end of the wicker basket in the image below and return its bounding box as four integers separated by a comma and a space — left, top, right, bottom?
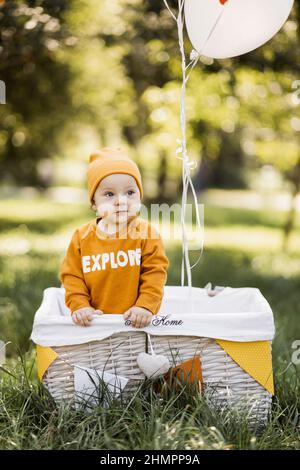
216, 339, 274, 395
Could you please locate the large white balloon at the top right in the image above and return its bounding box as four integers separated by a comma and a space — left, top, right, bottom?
185, 0, 294, 59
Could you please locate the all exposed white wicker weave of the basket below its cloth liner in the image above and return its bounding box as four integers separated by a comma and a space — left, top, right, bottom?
43, 332, 272, 427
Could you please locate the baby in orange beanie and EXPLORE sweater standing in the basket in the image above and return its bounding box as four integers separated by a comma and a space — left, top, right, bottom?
60, 147, 169, 328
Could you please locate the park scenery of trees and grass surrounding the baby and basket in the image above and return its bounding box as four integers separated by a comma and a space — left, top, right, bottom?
0, 0, 300, 449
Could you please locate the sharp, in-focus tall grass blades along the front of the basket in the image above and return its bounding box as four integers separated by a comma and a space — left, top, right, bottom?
0, 354, 300, 450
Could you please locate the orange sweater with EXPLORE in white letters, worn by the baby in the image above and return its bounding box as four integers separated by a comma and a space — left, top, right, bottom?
60, 217, 169, 314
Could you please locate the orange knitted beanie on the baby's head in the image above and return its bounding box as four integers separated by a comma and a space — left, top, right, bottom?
87, 147, 143, 202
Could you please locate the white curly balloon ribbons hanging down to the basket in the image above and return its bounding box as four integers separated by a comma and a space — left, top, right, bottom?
164, 0, 205, 296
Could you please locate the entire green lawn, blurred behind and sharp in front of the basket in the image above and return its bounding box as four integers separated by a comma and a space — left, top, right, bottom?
0, 196, 300, 449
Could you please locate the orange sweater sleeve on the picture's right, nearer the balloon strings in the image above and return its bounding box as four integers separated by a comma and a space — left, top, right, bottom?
135, 227, 169, 315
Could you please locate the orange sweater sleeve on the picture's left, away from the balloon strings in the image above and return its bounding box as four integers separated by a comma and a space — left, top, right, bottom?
60, 230, 90, 313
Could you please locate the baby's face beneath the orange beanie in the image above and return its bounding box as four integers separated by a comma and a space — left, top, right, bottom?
92, 173, 141, 223
